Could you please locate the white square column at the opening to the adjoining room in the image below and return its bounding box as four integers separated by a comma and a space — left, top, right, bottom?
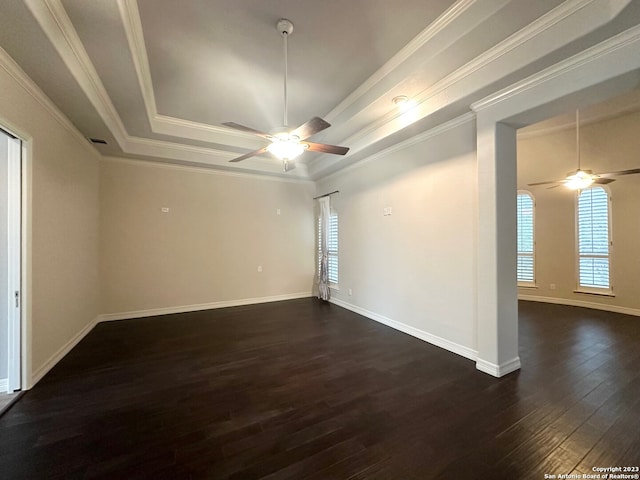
476, 118, 520, 377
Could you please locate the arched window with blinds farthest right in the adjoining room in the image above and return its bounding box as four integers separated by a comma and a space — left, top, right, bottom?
577, 187, 611, 293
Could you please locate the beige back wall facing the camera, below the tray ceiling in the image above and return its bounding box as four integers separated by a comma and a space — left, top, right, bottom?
100, 159, 314, 314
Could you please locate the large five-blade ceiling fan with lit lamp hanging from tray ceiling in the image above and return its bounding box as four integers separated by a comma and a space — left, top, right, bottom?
223, 18, 349, 172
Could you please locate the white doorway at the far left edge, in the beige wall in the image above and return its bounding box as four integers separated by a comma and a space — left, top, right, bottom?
0, 125, 22, 400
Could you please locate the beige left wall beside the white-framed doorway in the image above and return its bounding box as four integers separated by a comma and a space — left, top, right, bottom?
0, 57, 100, 382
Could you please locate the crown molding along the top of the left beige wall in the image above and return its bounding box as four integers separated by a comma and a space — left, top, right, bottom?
0, 47, 100, 155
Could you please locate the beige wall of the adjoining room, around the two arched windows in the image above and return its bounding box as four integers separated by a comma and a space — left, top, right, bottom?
518, 113, 640, 314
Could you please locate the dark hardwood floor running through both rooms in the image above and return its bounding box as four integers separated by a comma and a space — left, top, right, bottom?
0, 299, 640, 480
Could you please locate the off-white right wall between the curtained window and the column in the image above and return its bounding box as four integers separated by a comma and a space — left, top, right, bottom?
317, 116, 477, 356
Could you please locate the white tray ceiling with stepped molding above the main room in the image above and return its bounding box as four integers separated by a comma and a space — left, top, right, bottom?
0, 0, 640, 179
